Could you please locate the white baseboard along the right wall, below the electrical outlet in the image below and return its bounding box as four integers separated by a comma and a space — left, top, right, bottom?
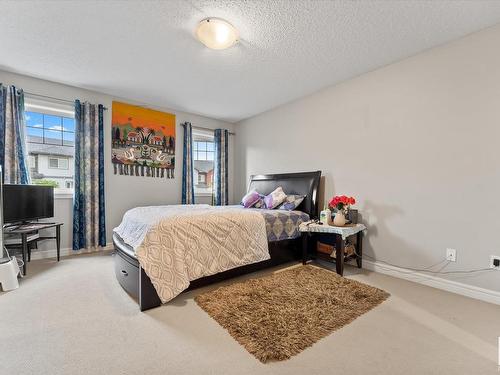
363, 259, 500, 305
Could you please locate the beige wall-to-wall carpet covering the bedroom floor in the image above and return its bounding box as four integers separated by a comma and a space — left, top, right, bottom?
0, 255, 500, 375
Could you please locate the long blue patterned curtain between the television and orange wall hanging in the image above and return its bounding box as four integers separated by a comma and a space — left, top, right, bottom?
73, 100, 106, 250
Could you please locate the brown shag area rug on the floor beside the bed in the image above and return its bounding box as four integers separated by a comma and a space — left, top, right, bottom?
195, 265, 389, 363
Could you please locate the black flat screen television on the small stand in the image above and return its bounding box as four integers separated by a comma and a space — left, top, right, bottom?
3, 184, 54, 223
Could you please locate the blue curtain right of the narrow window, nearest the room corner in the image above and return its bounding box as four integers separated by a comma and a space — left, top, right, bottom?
212, 129, 229, 206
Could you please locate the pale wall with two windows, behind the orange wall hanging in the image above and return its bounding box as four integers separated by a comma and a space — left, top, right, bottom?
0, 71, 233, 253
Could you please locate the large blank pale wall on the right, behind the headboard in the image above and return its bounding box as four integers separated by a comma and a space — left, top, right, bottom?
235, 26, 500, 291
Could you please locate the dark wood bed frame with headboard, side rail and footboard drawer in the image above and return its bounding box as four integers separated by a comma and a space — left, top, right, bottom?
113, 171, 321, 311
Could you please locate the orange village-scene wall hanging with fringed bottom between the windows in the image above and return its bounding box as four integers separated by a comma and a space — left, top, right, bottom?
111, 102, 175, 178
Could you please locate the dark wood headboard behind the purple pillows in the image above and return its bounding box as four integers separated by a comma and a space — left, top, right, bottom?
248, 171, 321, 218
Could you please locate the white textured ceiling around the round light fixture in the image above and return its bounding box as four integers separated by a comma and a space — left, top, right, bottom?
0, 0, 500, 122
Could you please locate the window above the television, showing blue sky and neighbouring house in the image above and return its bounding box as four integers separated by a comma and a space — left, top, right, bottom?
25, 100, 75, 193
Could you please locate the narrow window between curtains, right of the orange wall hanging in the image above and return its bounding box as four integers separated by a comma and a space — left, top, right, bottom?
193, 133, 215, 195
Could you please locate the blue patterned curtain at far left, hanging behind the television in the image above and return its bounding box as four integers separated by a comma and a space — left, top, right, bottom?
0, 84, 31, 184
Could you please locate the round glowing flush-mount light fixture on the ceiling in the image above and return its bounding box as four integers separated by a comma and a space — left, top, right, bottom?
196, 18, 238, 49
